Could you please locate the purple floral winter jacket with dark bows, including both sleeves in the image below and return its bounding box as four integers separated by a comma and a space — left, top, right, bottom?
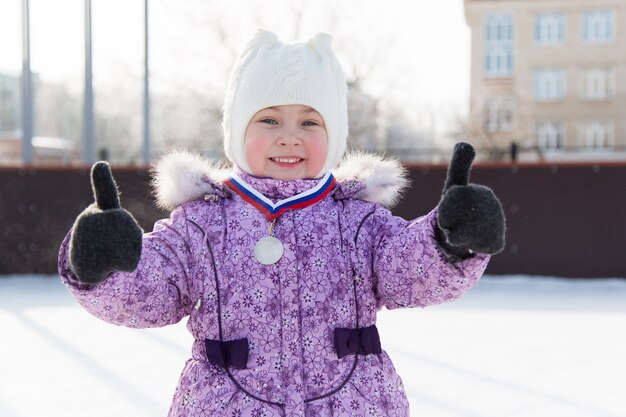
59, 154, 488, 417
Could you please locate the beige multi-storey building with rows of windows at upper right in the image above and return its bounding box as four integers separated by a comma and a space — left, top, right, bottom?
465, 0, 626, 159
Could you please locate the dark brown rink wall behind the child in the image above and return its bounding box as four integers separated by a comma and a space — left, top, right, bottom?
0, 163, 626, 277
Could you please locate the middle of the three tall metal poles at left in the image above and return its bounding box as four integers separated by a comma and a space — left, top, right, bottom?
83, 0, 95, 165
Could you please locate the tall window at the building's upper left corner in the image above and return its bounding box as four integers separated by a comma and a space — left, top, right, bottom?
485, 14, 513, 77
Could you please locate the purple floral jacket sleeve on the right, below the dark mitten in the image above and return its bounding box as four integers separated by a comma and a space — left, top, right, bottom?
371, 207, 489, 309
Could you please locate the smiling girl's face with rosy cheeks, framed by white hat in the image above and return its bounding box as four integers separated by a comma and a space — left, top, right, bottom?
243, 104, 328, 180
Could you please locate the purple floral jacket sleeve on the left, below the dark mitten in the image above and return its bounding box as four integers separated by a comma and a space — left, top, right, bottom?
58, 207, 193, 328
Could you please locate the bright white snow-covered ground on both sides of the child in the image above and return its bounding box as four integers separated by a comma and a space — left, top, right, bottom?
0, 276, 626, 417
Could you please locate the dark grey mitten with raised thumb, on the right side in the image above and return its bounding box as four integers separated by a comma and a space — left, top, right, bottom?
435, 142, 506, 260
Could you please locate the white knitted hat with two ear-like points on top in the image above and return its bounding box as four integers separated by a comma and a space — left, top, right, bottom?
222, 30, 348, 178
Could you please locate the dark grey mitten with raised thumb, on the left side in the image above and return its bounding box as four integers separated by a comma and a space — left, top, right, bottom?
70, 161, 143, 284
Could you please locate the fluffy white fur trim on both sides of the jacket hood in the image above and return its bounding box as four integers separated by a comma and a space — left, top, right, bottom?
152, 151, 409, 210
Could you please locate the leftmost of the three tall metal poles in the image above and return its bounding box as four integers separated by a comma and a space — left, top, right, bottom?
22, 0, 33, 164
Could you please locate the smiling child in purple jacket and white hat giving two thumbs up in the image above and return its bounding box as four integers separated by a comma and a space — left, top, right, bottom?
59, 31, 504, 417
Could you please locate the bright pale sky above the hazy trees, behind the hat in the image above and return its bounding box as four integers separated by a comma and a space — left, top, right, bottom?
0, 0, 469, 128
